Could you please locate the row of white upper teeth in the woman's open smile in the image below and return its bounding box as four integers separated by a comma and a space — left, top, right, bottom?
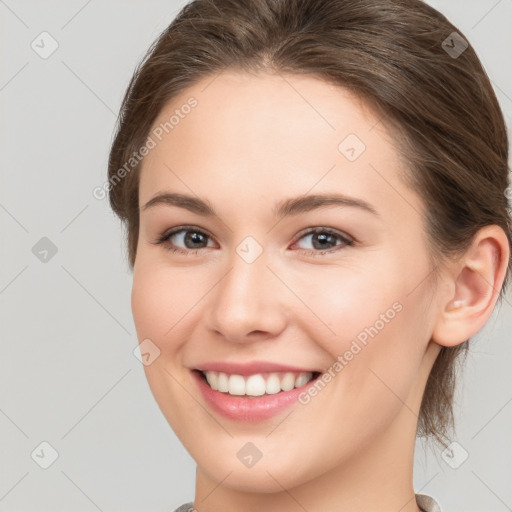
203, 371, 313, 396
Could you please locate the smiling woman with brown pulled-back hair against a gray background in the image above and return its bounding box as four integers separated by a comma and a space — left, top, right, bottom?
109, 0, 512, 512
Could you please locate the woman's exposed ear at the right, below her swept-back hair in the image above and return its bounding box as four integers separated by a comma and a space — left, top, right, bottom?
432, 225, 510, 347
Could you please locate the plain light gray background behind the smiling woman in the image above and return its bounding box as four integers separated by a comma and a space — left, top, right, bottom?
0, 0, 512, 512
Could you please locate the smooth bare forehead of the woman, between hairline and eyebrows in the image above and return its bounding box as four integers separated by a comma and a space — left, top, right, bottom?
139, 71, 420, 220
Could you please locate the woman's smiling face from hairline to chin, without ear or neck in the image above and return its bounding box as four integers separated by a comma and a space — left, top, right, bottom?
132, 72, 444, 492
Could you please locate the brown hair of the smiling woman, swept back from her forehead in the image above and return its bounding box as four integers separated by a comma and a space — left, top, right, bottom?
108, 0, 512, 445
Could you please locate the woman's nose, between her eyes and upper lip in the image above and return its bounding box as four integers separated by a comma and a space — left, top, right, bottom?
206, 244, 286, 343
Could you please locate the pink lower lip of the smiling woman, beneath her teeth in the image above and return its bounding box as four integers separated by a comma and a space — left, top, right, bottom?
192, 371, 313, 422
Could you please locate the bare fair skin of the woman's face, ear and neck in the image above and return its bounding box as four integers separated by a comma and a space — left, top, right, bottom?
132, 70, 509, 512
